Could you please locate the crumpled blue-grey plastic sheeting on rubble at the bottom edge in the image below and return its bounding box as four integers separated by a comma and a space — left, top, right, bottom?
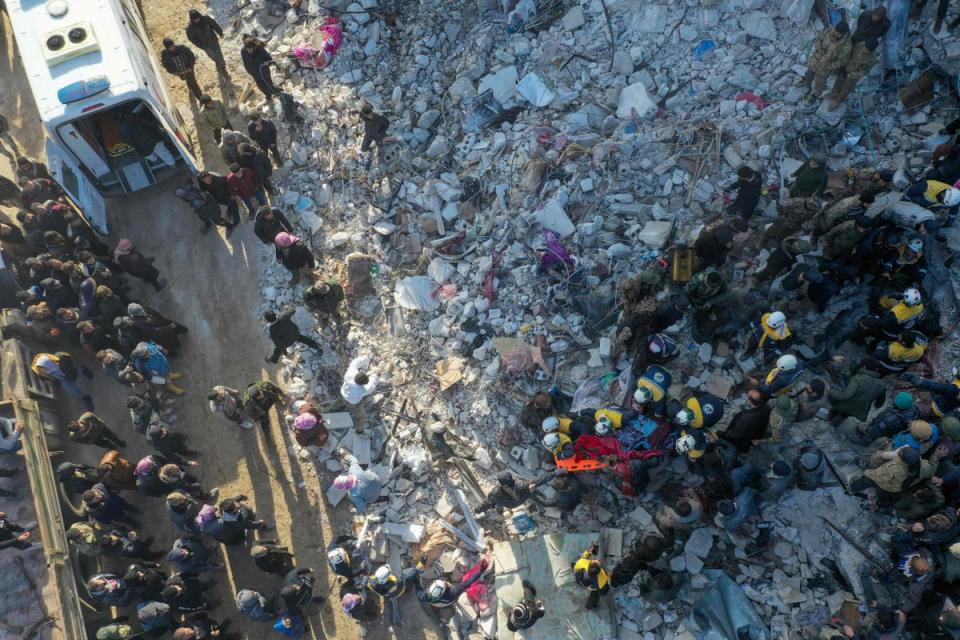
685, 569, 772, 640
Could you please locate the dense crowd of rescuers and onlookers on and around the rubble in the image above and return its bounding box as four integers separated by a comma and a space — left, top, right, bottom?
0, 2, 960, 640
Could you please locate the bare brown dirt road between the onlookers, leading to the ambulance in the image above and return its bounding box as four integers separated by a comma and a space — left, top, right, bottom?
0, 0, 436, 640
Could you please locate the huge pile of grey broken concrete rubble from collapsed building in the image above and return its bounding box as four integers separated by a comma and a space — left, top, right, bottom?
219, 0, 958, 638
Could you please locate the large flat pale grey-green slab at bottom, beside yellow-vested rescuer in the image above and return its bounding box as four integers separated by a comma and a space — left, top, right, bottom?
493, 533, 614, 640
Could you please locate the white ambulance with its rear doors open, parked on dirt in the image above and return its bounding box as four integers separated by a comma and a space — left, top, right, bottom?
6, 0, 197, 233
